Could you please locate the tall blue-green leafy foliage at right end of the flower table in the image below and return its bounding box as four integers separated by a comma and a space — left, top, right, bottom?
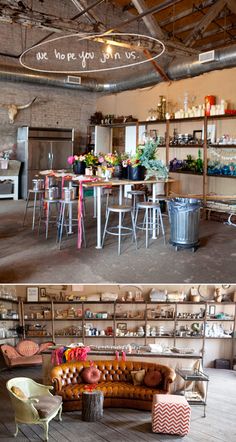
140, 139, 169, 180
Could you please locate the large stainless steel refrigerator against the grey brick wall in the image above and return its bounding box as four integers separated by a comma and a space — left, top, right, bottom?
17, 126, 74, 199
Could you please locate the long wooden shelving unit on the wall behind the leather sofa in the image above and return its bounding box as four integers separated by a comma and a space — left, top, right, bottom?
20, 299, 236, 368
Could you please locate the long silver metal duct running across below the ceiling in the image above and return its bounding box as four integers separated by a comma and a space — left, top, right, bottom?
0, 44, 236, 94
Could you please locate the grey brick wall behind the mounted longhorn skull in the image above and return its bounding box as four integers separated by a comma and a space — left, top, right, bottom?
0, 81, 96, 156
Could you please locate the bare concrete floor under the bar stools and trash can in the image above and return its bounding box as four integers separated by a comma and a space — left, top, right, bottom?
0, 197, 236, 284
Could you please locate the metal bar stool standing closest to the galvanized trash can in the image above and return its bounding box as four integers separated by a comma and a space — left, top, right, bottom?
135, 201, 166, 248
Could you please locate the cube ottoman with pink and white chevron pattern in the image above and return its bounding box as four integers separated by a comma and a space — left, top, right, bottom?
152, 394, 191, 436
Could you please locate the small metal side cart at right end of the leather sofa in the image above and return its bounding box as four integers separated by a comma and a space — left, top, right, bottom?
176, 368, 209, 417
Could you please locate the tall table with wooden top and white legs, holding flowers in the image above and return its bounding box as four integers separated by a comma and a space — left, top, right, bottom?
83, 178, 175, 249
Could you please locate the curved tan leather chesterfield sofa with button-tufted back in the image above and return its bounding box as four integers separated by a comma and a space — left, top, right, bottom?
51, 360, 175, 411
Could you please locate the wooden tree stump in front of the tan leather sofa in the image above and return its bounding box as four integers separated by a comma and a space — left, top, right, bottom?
82, 390, 103, 422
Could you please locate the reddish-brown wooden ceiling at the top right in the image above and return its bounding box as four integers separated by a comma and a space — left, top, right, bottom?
115, 0, 236, 52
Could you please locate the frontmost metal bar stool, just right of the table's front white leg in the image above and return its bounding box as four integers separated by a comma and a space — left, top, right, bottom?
102, 205, 137, 255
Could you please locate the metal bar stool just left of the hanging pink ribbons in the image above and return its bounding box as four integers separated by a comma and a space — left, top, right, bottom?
57, 200, 86, 249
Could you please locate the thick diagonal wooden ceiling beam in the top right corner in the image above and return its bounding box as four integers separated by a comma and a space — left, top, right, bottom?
184, 0, 227, 46
